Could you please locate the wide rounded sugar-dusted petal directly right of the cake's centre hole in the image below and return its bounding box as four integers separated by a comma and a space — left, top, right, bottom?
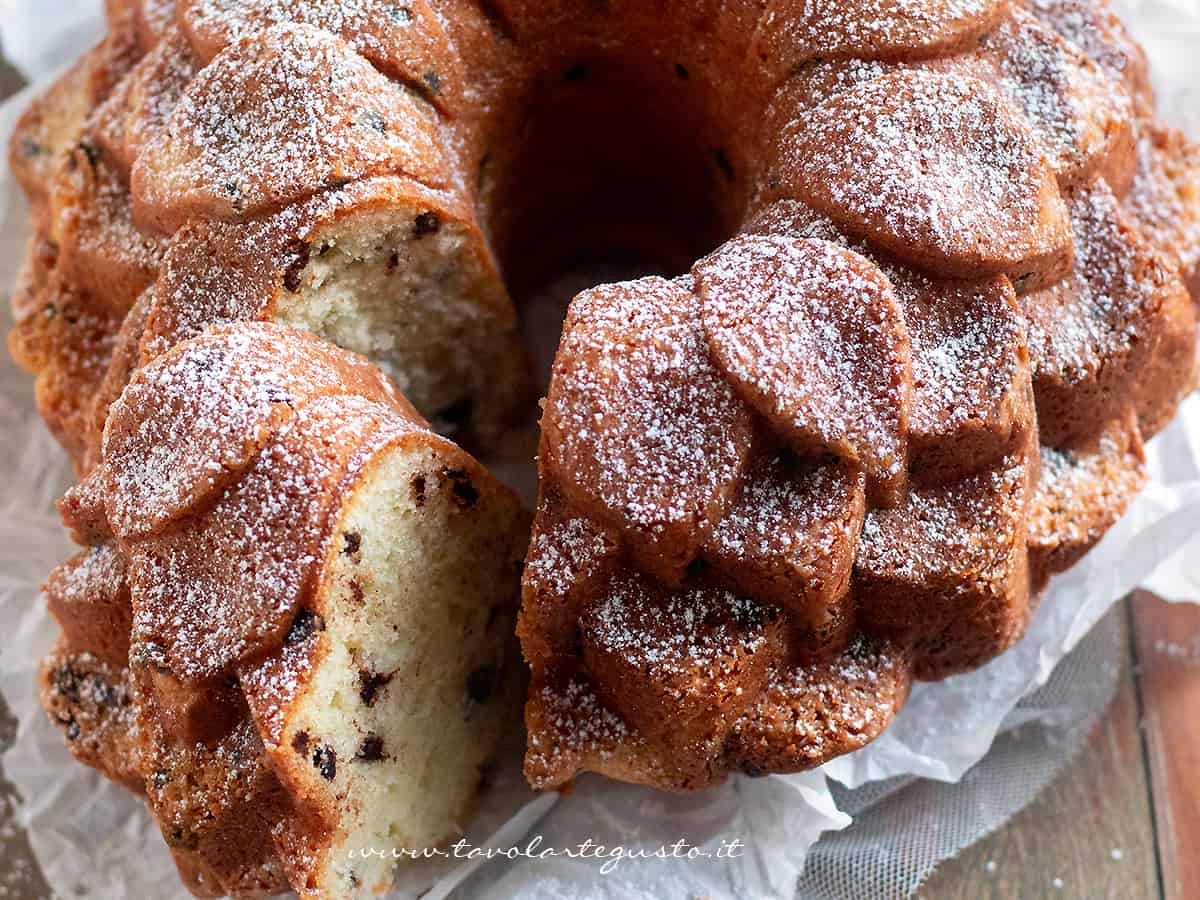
779, 71, 1068, 276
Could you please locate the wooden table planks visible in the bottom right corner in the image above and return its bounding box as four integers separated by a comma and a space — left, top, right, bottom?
919, 594, 1200, 900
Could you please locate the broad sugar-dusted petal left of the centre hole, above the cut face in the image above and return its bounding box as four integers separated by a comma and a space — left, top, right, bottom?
133, 25, 445, 222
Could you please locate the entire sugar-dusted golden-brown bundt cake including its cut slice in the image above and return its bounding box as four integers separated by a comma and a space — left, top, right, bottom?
10, 0, 1200, 896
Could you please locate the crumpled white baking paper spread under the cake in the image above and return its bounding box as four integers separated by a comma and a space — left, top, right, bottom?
0, 0, 1200, 900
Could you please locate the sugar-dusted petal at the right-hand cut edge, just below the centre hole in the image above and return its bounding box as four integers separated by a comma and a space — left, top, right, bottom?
544, 278, 751, 554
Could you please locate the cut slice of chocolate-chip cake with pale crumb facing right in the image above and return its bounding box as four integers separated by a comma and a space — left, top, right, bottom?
50, 323, 527, 898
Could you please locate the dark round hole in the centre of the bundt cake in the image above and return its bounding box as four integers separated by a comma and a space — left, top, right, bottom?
480, 52, 750, 386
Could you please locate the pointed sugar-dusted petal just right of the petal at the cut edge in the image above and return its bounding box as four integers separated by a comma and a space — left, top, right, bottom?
695, 236, 912, 496
